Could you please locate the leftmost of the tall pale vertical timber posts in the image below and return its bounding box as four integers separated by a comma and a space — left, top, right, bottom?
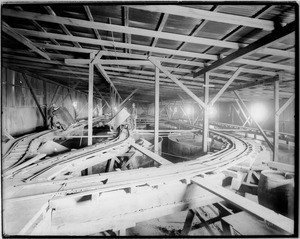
88, 59, 94, 146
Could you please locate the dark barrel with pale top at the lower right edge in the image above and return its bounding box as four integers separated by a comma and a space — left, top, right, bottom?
258, 170, 294, 218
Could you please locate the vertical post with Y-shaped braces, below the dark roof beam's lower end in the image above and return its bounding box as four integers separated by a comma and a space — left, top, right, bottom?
202, 72, 209, 153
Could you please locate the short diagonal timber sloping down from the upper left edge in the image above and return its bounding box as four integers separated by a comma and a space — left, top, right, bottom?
2, 21, 51, 60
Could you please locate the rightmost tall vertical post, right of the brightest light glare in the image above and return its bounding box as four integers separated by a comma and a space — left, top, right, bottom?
273, 75, 281, 162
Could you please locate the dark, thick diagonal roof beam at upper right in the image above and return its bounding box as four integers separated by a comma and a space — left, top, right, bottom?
193, 22, 296, 77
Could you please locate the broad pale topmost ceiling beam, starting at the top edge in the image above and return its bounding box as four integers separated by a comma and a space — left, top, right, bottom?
129, 5, 274, 31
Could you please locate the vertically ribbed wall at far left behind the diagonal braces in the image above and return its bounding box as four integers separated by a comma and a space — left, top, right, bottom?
1, 67, 102, 136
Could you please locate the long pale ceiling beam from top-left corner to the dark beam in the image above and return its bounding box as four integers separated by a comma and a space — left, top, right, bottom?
2, 8, 285, 57
